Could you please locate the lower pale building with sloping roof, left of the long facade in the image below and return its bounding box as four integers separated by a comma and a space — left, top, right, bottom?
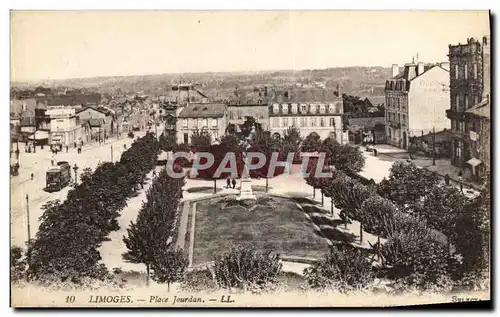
177, 103, 228, 144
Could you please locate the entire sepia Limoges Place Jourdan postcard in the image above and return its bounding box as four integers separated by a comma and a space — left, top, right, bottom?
9, 10, 492, 308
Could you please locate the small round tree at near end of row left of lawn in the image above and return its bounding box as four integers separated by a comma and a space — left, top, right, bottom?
151, 249, 189, 292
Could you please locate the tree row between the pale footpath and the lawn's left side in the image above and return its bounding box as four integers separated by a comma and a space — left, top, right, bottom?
123, 165, 188, 289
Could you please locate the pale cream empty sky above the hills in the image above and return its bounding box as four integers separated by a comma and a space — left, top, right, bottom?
10, 11, 489, 81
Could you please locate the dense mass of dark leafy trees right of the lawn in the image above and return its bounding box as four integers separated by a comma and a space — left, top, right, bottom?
307, 154, 488, 288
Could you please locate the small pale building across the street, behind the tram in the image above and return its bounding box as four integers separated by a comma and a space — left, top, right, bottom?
45, 106, 81, 146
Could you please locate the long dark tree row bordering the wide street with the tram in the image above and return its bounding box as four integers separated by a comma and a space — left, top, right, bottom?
21, 134, 158, 283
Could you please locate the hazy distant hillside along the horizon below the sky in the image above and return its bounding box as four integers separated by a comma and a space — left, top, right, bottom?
12, 67, 391, 97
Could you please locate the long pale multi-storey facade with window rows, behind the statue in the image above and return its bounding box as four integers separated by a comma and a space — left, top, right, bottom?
269, 98, 348, 143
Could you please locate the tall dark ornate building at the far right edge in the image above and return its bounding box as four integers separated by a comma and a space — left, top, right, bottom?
446, 36, 491, 179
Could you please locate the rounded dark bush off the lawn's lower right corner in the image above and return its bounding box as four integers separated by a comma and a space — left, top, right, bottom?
304, 244, 375, 292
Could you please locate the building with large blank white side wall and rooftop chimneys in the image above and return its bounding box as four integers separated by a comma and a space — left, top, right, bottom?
385, 62, 450, 149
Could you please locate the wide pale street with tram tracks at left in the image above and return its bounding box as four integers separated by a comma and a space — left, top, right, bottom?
10, 127, 161, 247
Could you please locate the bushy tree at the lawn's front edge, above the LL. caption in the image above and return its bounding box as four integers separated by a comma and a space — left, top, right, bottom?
214, 247, 282, 290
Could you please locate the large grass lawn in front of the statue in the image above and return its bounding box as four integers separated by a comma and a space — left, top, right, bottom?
193, 195, 328, 265
